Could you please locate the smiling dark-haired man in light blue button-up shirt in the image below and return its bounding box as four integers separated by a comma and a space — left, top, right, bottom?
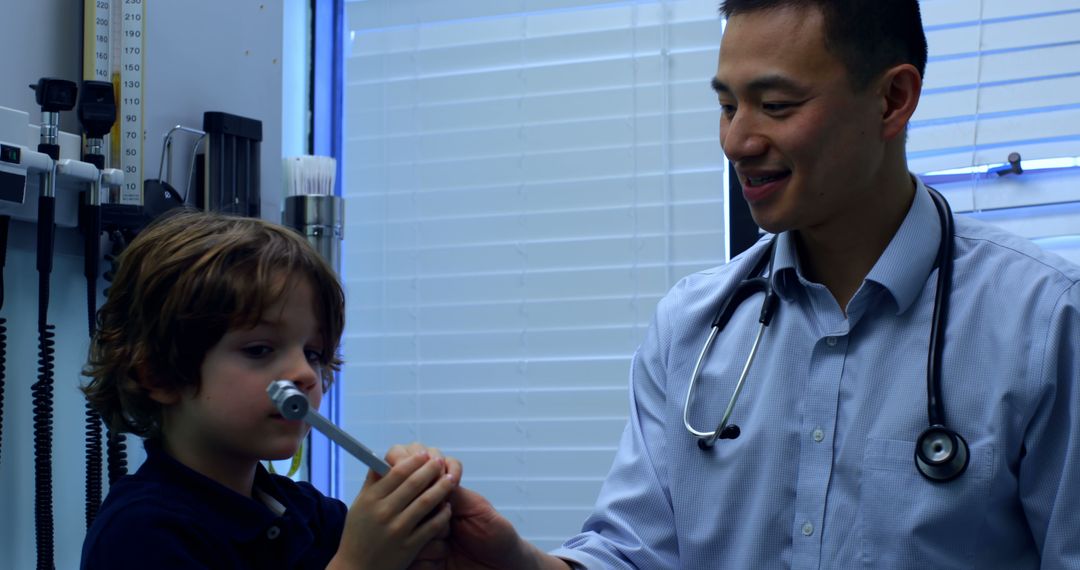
395, 0, 1080, 570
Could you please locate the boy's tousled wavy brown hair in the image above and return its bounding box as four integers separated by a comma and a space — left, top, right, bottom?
83, 209, 345, 438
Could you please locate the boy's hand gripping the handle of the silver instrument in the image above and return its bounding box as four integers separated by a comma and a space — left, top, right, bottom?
328, 451, 460, 569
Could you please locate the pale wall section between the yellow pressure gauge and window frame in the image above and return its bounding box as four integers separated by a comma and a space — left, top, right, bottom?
144, 0, 283, 220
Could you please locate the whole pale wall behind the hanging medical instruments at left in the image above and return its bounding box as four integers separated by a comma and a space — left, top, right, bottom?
0, 0, 295, 569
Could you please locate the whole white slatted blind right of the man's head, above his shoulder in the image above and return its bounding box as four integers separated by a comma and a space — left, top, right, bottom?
908, 0, 1080, 262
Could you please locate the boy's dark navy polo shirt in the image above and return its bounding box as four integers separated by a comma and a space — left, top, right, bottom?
82, 443, 348, 570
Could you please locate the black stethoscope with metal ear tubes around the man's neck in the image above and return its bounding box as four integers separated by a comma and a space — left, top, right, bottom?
683, 188, 968, 481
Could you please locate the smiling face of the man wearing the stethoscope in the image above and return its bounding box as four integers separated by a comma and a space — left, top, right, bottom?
714, 8, 883, 232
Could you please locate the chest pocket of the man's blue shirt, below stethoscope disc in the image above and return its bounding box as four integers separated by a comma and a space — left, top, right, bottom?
859, 438, 994, 570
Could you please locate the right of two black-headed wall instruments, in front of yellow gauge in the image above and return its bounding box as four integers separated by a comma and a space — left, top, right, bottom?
76, 81, 117, 528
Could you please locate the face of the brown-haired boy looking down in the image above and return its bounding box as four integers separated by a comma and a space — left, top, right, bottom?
157, 280, 325, 477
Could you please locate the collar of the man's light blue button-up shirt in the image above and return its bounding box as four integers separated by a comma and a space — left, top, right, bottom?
771, 176, 942, 314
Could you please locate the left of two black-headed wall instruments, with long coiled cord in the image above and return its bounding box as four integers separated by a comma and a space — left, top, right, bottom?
30, 78, 78, 570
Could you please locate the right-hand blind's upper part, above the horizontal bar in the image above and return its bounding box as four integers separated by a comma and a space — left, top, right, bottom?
908, 0, 1080, 172
